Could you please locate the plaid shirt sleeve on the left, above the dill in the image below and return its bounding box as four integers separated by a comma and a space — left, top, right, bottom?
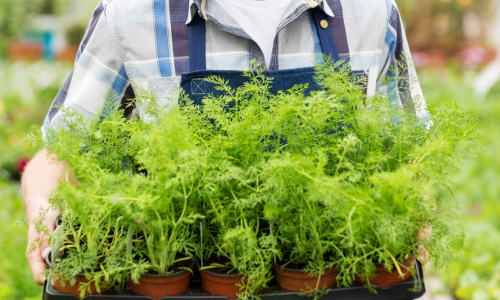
42, 2, 129, 138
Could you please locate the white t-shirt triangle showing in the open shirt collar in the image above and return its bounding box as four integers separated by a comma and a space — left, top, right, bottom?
216, 0, 292, 67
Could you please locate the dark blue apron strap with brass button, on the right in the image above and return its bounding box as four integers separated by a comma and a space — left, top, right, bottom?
312, 7, 340, 61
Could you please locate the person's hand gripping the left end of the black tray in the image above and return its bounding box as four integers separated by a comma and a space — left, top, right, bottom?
26, 204, 60, 286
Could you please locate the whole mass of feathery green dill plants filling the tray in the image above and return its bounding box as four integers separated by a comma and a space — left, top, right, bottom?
29, 59, 480, 298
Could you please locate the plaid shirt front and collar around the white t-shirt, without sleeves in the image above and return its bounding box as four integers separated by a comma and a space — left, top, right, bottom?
102, 0, 392, 87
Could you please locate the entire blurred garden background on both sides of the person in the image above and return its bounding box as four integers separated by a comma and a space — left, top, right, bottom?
0, 0, 500, 300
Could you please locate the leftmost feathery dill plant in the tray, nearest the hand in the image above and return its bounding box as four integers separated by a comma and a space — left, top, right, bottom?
27, 92, 145, 296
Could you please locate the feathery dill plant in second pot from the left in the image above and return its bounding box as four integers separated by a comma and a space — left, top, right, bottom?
123, 108, 204, 280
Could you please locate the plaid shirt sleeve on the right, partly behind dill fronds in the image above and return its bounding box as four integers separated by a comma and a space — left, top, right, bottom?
377, 2, 430, 120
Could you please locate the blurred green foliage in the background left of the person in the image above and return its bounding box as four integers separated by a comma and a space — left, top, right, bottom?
0, 61, 71, 300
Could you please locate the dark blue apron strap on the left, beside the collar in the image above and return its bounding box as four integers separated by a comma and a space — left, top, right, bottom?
189, 13, 207, 72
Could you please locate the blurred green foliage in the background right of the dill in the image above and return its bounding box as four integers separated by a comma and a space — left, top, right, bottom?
420, 67, 500, 300
